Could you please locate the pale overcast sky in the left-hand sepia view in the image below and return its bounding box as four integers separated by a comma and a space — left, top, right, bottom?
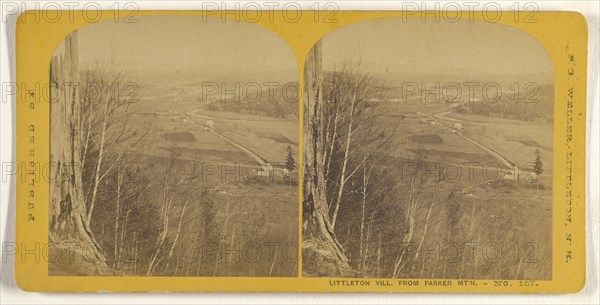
79, 16, 297, 72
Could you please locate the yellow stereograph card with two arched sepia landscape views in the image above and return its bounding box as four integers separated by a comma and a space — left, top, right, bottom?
16, 11, 587, 293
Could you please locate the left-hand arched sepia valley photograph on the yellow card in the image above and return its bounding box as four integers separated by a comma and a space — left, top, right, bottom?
48, 15, 299, 277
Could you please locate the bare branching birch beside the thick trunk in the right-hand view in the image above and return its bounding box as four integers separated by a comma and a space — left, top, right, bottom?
323, 63, 395, 229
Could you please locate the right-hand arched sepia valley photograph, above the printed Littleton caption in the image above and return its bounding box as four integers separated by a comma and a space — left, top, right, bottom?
302, 17, 554, 278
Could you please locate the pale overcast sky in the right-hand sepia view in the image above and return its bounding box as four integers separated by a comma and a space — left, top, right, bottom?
323, 18, 552, 74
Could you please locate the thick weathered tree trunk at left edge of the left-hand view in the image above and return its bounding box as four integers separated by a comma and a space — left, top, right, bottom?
49, 32, 108, 273
